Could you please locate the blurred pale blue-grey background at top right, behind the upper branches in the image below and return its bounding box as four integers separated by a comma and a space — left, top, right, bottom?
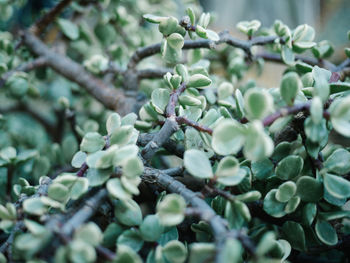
200, 0, 350, 87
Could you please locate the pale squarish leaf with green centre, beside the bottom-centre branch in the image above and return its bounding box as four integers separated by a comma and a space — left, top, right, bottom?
157, 194, 186, 226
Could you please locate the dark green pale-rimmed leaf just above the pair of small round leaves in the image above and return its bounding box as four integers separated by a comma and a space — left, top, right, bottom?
275, 155, 304, 180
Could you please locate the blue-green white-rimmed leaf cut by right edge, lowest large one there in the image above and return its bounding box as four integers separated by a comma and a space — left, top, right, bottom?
323, 173, 350, 198
